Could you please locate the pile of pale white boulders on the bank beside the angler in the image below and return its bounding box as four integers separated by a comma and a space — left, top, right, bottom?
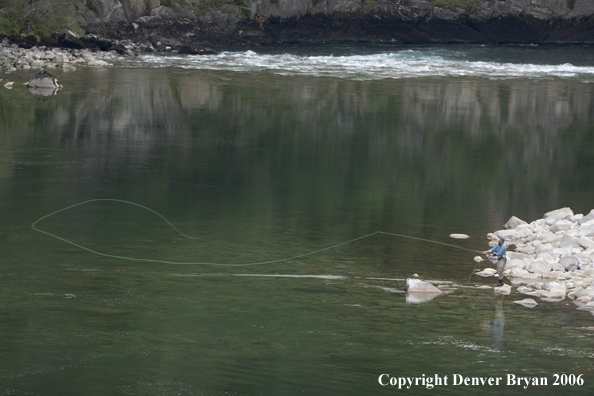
477, 208, 594, 315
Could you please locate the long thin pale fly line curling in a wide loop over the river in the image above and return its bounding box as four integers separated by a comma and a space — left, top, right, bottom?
31, 198, 475, 267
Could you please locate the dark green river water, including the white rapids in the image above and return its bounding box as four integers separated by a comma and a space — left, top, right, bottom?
0, 46, 594, 396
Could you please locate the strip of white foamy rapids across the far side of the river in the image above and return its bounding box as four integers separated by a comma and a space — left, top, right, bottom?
135, 48, 594, 81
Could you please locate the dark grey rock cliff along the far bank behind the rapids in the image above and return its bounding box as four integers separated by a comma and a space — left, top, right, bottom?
79, 0, 594, 46
